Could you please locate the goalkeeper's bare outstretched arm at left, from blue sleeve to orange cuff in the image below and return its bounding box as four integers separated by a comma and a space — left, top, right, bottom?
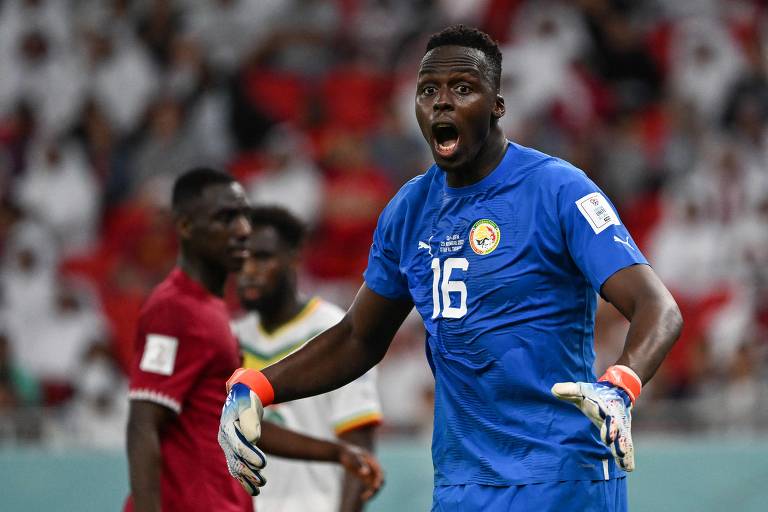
264, 284, 413, 402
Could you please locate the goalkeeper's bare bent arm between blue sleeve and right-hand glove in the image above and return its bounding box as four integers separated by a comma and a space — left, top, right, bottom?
601, 265, 683, 384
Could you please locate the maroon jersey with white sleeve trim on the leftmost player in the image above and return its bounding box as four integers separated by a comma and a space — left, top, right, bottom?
125, 268, 252, 512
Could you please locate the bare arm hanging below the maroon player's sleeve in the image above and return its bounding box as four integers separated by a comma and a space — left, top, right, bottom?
127, 400, 176, 512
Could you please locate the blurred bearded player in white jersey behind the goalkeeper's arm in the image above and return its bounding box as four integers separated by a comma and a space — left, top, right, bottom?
233, 207, 381, 512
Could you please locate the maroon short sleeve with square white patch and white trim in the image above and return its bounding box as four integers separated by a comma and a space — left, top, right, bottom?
128, 307, 210, 413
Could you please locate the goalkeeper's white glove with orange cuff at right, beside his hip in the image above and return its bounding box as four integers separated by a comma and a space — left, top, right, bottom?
552, 365, 642, 471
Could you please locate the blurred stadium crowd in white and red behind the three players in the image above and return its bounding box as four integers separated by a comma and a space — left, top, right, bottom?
0, 0, 768, 511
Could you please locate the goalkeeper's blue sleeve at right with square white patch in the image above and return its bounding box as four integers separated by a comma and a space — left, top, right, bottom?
558, 168, 648, 293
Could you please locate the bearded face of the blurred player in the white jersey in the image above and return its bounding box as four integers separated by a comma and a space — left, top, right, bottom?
237, 226, 297, 311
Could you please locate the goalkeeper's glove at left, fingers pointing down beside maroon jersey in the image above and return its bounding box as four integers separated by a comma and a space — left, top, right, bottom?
218, 368, 274, 496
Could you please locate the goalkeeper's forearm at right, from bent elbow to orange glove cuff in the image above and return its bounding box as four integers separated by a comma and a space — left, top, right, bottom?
616, 296, 683, 384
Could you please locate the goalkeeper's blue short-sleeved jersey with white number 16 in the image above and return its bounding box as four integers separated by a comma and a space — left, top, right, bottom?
365, 142, 647, 485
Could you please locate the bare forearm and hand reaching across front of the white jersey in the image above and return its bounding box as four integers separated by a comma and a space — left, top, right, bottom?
258, 421, 384, 500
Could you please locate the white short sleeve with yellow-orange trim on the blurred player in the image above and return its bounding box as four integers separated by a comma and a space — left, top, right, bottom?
329, 368, 382, 435
